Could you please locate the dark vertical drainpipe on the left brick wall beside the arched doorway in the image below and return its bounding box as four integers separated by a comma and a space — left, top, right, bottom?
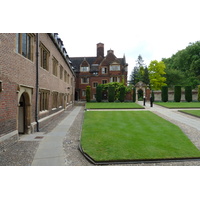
35, 33, 39, 132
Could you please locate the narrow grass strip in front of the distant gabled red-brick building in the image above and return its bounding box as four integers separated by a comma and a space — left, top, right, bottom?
86, 102, 143, 109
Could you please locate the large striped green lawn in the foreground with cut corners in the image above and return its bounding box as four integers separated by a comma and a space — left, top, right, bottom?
81, 111, 200, 161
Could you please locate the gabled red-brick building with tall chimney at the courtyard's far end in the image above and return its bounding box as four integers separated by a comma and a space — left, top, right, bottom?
70, 43, 128, 100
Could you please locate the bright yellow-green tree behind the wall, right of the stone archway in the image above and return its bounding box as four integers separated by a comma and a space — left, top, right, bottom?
148, 60, 167, 90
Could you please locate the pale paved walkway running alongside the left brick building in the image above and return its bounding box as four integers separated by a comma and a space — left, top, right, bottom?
32, 107, 81, 166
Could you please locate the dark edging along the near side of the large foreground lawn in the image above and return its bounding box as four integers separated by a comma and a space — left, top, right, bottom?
78, 143, 200, 165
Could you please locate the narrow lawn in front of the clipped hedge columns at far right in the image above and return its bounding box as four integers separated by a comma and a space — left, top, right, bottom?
155, 102, 200, 108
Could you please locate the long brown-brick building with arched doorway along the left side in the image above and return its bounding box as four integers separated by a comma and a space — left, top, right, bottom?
0, 33, 75, 151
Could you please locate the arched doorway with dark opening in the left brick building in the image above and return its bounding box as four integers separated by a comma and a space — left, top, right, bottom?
18, 92, 30, 134
